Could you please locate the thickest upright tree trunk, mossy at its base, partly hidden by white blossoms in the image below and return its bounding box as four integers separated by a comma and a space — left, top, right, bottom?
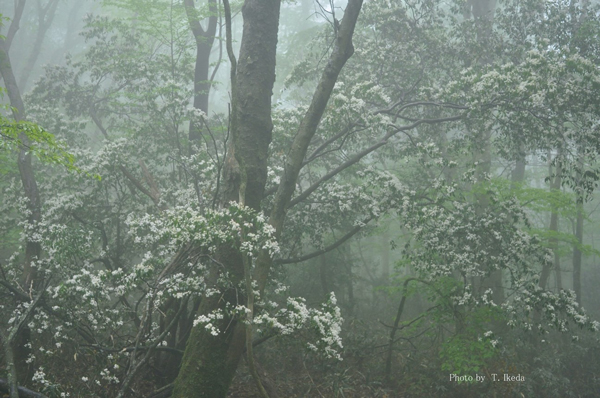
173, 0, 280, 398
